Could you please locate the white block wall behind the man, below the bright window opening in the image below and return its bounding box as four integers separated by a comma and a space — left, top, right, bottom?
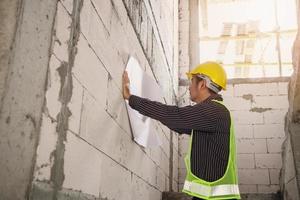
179, 82, 288, 193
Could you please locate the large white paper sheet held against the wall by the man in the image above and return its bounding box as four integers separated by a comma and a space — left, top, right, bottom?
126, 57, 163, 147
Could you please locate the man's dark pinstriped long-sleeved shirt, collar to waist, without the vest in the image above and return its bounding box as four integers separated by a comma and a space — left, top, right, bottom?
129, 94, 231, 182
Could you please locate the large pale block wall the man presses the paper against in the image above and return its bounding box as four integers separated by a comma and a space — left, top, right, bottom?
31, 0, 178, 200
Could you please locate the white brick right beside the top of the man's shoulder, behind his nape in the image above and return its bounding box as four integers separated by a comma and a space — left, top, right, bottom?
224, 97, 251, 111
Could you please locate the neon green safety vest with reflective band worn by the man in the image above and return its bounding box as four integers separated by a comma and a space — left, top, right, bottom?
182, 100, 241, 199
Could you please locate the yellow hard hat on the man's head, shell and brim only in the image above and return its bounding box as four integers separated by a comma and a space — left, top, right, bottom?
186, 61, 227, 90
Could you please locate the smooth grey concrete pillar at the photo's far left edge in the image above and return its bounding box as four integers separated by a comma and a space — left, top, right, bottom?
0, 0, 57, 200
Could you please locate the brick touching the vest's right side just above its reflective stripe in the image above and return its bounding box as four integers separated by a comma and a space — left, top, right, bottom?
238, 169, 270, 185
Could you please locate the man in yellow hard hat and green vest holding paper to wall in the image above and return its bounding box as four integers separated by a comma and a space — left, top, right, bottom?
123, 62, 240, 200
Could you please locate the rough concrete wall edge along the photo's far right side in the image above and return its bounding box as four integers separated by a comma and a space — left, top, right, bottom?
280, 0, 300, 200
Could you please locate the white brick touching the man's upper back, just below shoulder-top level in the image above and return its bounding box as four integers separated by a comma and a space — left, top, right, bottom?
231, 111, 263, 125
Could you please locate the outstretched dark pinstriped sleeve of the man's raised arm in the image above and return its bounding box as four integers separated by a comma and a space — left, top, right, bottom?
129, 95, 224, 134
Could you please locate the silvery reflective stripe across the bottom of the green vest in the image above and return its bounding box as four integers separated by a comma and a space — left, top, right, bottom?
183, 181, 240, 197
